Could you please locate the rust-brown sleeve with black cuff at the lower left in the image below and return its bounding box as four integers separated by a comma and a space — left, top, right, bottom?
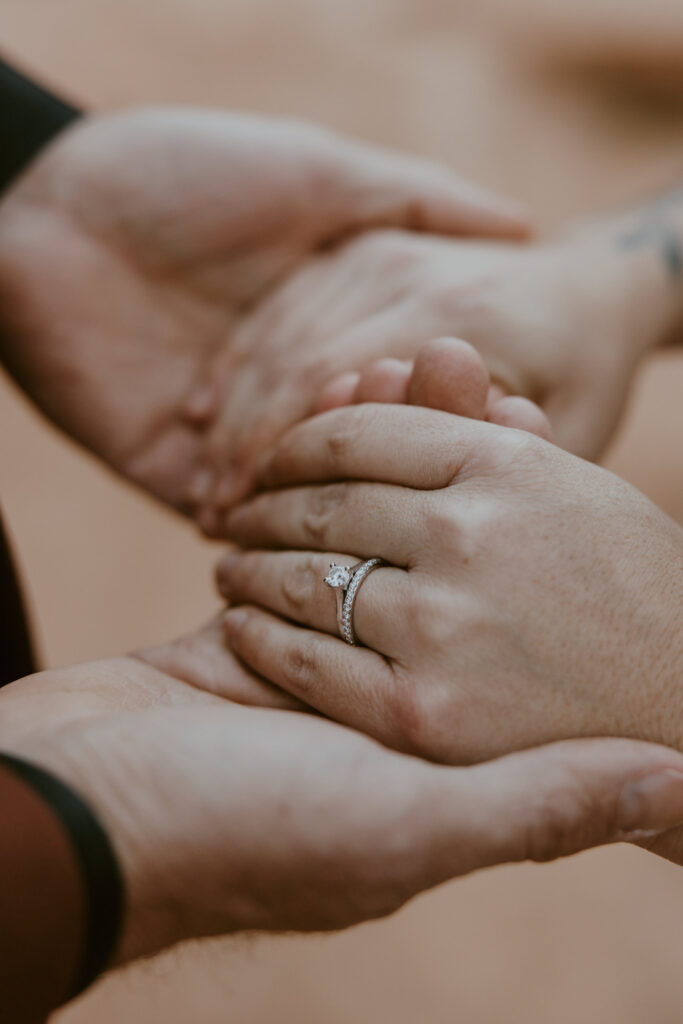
0, 755, 123, 1024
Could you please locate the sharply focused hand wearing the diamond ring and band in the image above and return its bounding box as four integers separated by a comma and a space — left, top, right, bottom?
219, 404, 683, 762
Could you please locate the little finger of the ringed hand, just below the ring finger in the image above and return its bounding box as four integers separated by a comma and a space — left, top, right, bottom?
224, 606, 404, 750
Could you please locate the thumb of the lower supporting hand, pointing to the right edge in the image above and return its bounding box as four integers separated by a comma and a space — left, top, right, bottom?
423, 739, 683, 885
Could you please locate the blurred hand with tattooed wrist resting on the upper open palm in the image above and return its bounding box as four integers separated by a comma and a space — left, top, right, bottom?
198, 212, 682, 534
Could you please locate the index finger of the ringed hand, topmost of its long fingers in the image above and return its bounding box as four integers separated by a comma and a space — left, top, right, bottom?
259, 403, 499, 489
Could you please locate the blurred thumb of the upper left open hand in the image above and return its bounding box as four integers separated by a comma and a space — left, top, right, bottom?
323, 140, 530, 239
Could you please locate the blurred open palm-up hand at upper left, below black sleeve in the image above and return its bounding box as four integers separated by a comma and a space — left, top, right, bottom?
0, 110, 525, 511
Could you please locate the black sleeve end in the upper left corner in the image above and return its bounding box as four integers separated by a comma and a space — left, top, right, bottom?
0, 59, 81, 193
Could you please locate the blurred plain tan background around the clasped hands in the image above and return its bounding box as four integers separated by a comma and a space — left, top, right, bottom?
0, 0, 683, 1024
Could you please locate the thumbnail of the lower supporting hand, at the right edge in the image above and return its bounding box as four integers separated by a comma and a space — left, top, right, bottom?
617, 768, 683, 833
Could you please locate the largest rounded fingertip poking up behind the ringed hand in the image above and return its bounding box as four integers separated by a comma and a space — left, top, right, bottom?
408, 338, 489, 420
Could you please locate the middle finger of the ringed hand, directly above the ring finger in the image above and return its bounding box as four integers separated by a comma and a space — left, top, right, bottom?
224, 482, 430, 566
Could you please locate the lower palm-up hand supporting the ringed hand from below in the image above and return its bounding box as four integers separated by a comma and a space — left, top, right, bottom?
0, 658, 683, 964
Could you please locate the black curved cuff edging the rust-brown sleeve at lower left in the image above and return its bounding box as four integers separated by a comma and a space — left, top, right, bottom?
0, 755, 124, 999
